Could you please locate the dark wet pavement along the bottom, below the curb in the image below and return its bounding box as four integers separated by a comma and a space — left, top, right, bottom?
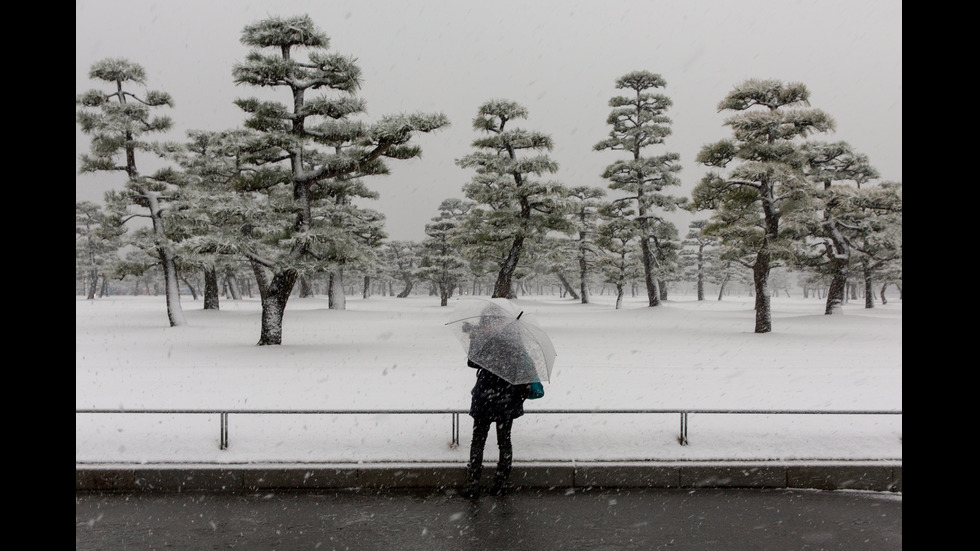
75, 488, 902, 551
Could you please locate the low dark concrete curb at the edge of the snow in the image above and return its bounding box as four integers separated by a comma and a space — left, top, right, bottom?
75, 461, 902, 493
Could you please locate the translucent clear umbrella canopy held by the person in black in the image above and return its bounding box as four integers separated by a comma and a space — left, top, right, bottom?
446, 298, 557, 385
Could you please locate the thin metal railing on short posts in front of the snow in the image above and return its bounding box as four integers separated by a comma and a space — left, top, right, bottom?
75, 408, 902, 450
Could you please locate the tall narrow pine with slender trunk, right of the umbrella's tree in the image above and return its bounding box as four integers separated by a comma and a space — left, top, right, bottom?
594, 71, 685, 306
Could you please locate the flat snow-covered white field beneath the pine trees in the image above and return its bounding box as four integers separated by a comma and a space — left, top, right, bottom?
75, 296, 902, 464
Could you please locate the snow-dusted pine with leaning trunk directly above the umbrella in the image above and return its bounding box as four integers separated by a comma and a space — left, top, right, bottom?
456, 100, 570, 297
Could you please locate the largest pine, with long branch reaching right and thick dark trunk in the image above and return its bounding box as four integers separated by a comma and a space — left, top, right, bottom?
233, 15, 448, 345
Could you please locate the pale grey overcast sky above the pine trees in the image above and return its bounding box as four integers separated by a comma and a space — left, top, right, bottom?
75, 0, 902, 241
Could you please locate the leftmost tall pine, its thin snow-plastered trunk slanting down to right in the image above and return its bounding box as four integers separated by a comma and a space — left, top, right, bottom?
75, 58, 187, 327
